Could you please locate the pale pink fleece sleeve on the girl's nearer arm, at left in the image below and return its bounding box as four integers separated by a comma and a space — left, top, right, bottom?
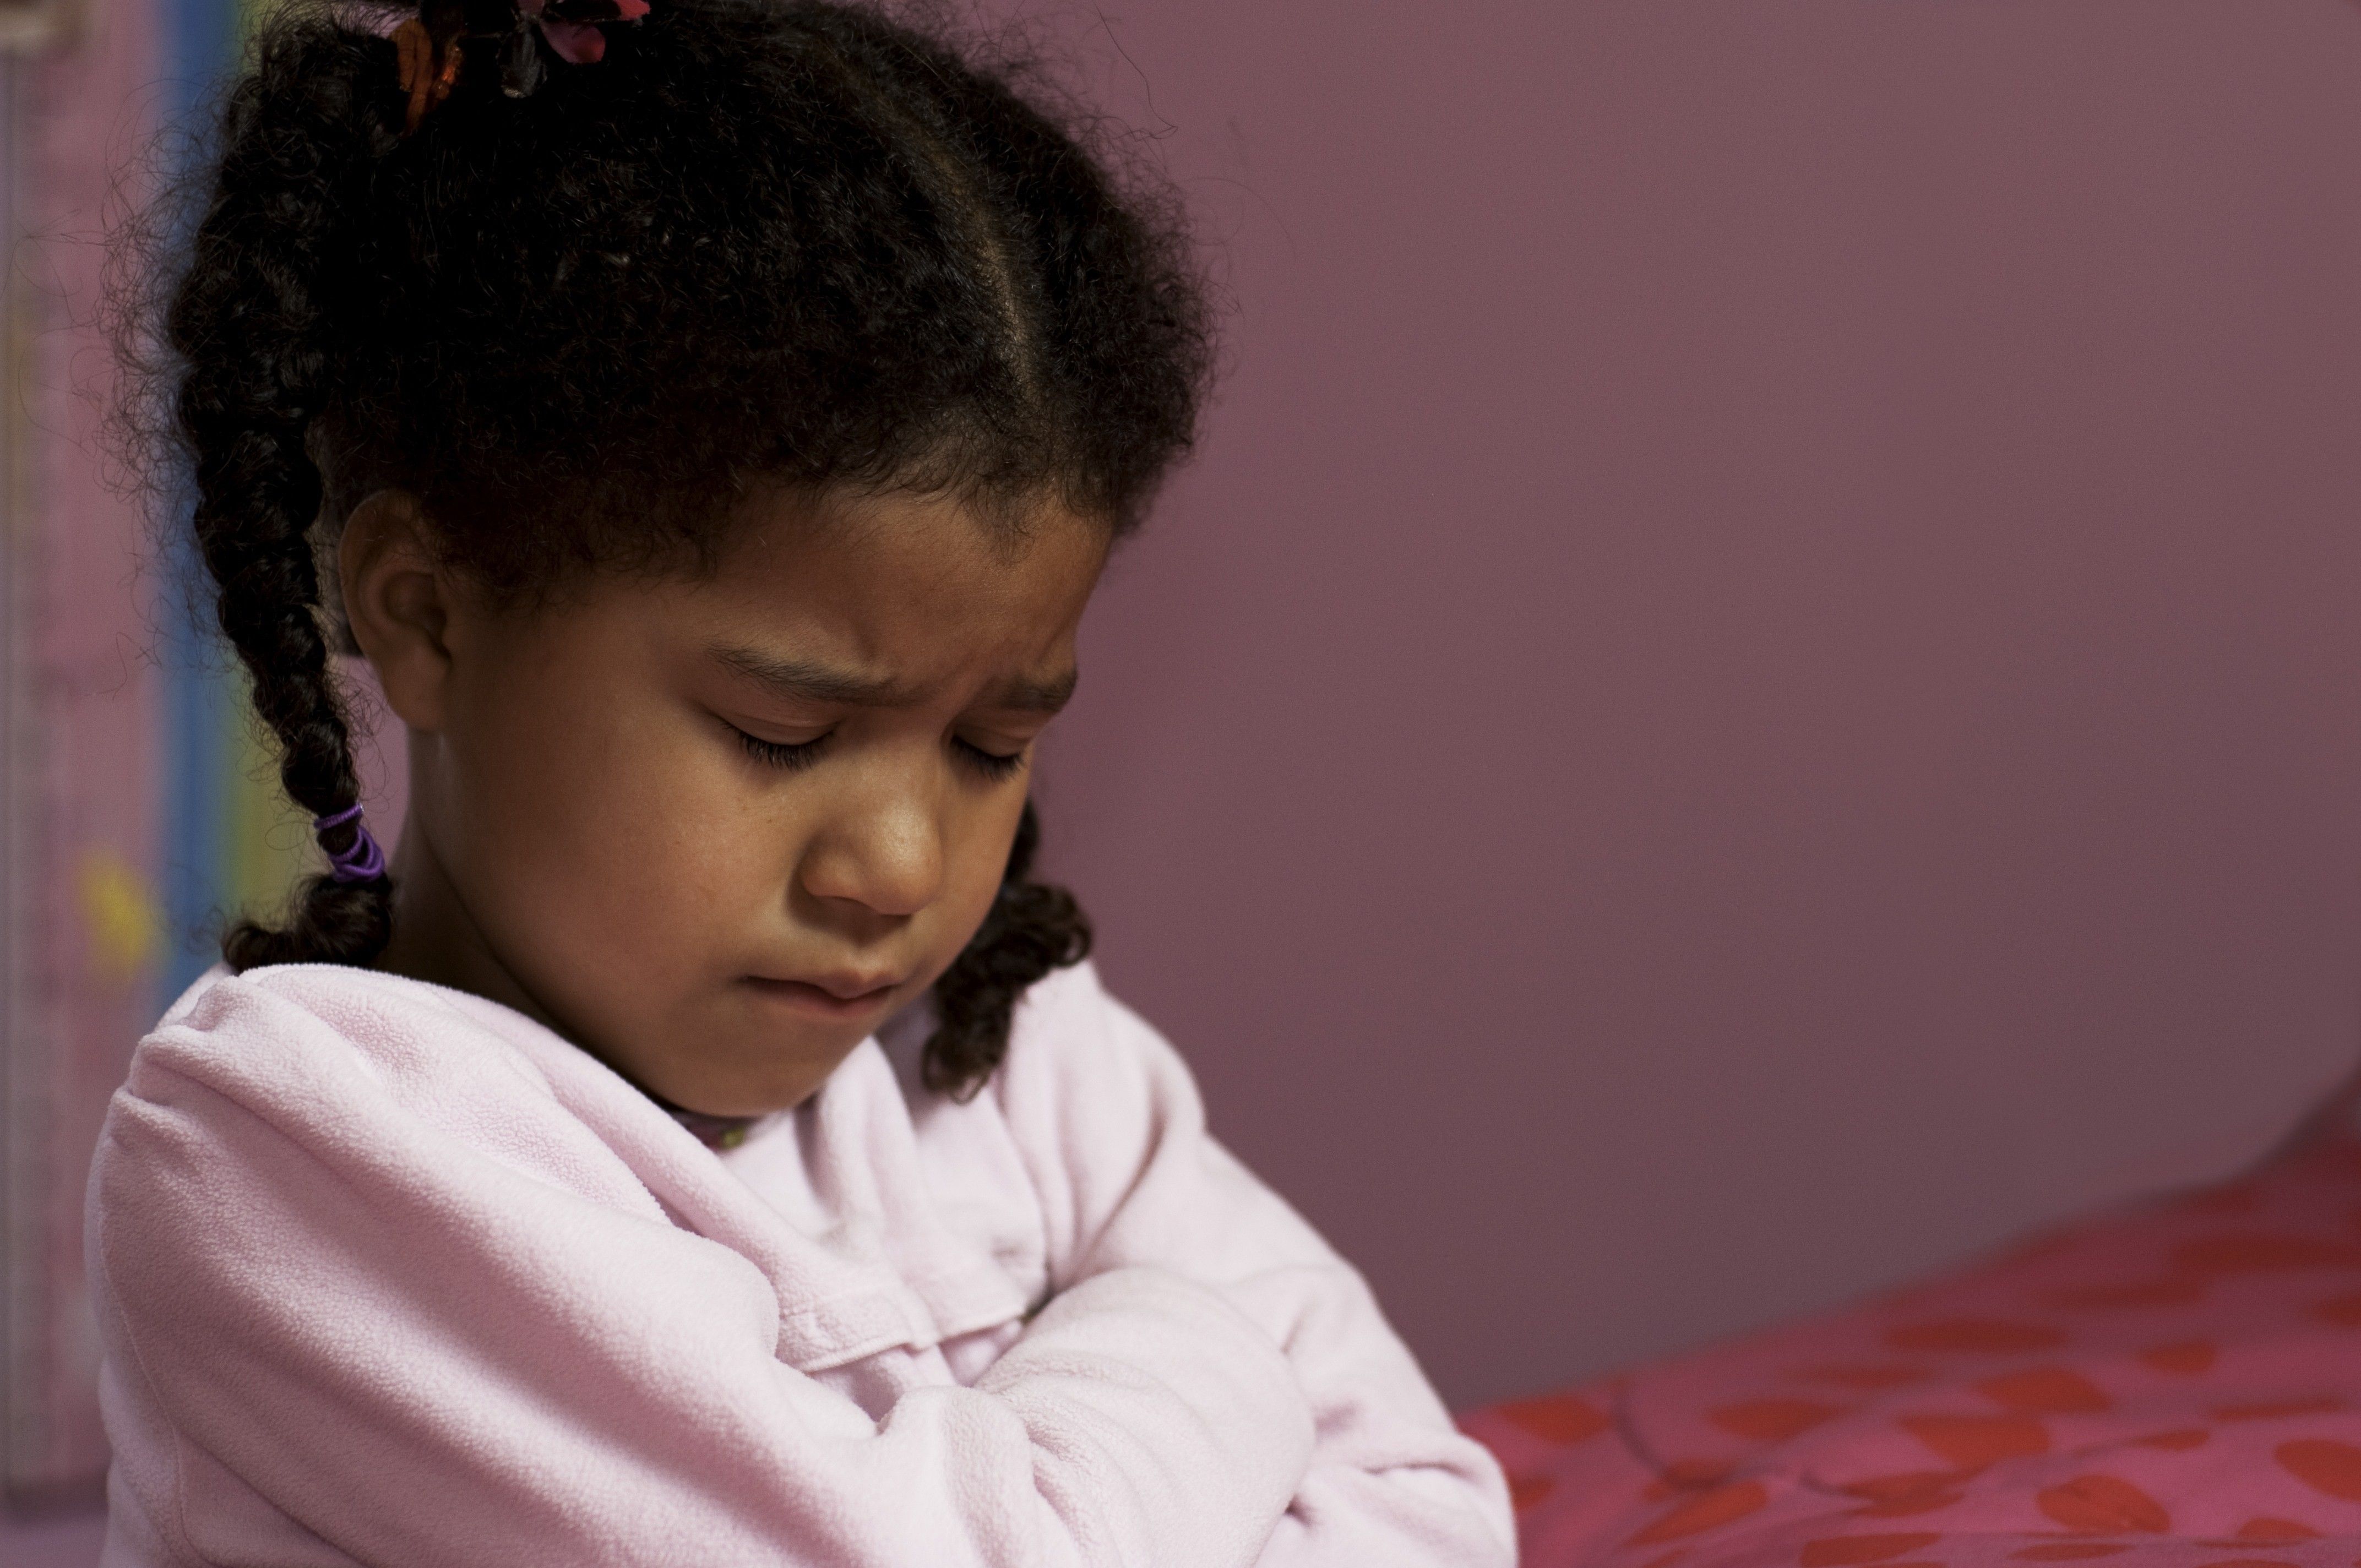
90, 980, 1310, 1568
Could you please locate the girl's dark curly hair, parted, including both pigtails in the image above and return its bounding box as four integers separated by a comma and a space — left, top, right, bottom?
134, 0, 1209, 1093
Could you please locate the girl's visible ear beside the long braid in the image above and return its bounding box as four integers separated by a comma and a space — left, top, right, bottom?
335, 489, 460, 734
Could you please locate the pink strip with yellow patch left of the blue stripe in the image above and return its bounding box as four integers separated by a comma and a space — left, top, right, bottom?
0, 5, 161, 1501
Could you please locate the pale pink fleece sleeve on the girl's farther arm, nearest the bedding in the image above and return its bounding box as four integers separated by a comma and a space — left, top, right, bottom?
997, 966, 1516, 1568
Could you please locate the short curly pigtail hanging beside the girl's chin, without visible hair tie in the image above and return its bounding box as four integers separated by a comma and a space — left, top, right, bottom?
921, 801, 1091, 1101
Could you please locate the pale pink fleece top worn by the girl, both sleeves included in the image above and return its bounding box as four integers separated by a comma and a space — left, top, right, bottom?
90, 966, 1514, 1568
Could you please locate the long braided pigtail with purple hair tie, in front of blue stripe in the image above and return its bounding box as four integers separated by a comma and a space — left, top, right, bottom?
165, 31, 399, 971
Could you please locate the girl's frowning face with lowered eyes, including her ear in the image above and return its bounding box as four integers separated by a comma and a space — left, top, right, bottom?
340, 493, 1107, 1114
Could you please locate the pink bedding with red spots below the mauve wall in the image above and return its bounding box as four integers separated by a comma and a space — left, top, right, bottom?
1464, 1141, 2361, 1568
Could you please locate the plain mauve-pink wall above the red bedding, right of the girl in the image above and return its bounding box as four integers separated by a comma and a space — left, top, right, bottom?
1046, 0, 2361, 1403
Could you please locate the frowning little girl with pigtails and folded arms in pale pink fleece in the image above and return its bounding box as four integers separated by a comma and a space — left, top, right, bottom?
90, 0, 1514, 1568
